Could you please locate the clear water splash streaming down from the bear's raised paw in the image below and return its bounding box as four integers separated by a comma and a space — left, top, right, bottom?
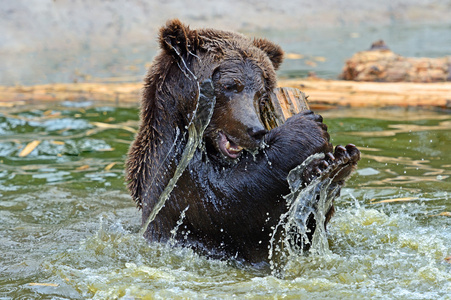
268, 153, 339, 273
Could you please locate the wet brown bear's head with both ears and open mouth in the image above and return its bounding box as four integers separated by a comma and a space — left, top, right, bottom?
157, 20, 283, 161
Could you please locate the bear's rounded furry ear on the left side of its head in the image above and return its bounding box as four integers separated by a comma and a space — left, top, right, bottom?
159, 19, 201, 57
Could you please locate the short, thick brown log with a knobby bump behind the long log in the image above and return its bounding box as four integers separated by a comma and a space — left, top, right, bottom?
340, 41, 451, 82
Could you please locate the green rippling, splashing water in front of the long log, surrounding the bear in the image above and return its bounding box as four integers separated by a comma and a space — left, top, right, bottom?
0, 102, 451, 299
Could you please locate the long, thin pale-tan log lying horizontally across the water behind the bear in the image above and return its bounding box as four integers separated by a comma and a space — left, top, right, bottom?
0, 79, 451, 110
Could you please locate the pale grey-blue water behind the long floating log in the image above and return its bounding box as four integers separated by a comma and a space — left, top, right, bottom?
0, 22, 451, 85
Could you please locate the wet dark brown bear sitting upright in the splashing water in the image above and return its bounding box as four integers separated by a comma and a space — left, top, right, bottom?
126, 20, 360, 263
